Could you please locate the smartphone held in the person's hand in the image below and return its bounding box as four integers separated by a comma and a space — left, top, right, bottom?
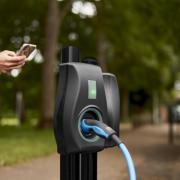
16, 44, 36, 58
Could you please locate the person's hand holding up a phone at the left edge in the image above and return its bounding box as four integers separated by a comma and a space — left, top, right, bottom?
0, 50, 26, 73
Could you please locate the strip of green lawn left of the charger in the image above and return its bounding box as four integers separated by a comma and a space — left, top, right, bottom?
0, 126, 56, 166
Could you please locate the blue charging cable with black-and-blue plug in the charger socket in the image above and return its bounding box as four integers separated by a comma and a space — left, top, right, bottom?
81, 119, 136, 180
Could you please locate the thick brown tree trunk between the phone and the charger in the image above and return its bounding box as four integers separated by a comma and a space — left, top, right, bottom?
40, 0, 60, 127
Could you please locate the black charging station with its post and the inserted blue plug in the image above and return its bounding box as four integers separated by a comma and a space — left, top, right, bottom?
54, 46, 135, 180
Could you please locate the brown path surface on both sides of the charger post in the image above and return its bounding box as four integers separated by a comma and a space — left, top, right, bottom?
0, 125, 180, 180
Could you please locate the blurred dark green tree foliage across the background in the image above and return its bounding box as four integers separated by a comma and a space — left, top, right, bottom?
0, 0, 180, 117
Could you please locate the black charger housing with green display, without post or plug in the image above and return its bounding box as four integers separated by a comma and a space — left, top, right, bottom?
54, 46, 120, 155
